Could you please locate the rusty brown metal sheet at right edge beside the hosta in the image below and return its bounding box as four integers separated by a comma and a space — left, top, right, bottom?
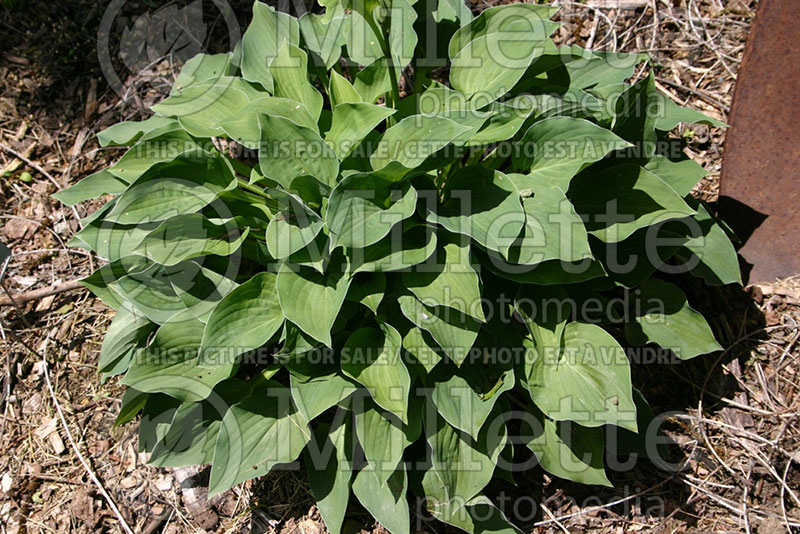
719, 0, 800, 283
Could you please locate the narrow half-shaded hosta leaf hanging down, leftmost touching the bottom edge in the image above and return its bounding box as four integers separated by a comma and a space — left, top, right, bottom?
304, 420, 353, 534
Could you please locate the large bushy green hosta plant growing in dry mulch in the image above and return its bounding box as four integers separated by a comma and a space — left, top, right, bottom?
58, 0, 739, 534
